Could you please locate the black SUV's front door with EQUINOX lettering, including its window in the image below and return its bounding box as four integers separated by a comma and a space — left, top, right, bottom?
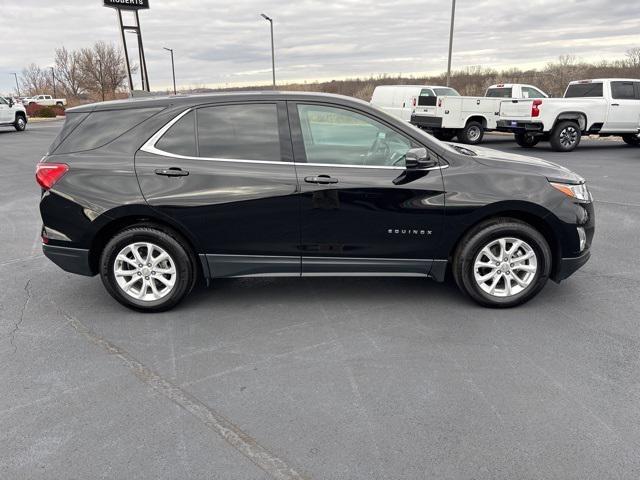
289, 102, 444, 275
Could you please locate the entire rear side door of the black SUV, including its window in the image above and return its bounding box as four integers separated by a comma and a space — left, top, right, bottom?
135, 102, 300, 277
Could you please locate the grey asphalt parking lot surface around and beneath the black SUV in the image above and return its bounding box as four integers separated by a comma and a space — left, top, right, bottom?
0, 122, 640, 480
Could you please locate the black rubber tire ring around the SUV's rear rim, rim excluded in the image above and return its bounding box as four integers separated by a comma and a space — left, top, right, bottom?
100, 227, 195, 312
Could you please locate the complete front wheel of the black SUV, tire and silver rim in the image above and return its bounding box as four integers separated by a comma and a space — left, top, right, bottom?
452, 218, 553, 308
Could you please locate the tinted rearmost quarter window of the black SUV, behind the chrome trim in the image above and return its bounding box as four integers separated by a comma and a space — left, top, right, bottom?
55, 108, 162, 153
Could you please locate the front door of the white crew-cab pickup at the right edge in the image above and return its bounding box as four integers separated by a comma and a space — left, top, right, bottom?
602, 80, 640, 133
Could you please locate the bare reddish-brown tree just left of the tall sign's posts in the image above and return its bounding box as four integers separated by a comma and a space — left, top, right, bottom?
78, 42, 127, 101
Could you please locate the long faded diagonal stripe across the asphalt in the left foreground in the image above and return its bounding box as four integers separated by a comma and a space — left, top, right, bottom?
56, 304, 310, 480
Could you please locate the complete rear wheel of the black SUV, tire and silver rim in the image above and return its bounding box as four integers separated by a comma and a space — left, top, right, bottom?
100, 226, 197, 312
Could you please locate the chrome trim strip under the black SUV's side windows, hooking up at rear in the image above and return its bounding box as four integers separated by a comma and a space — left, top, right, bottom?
140, 108, 449, 171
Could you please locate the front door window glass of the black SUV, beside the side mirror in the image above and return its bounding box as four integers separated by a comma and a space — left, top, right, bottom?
298, 105, 412, 166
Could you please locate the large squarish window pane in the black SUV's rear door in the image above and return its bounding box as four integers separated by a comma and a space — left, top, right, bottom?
197, 103, 282, 162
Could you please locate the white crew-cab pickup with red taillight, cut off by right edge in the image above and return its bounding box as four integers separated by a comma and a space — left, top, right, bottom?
498, 78, 640, 152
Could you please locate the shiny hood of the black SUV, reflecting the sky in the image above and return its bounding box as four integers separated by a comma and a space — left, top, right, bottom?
449, 143, 584, 184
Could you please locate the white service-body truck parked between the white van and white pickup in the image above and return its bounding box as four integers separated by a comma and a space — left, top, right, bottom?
411, 83, 547, 145
